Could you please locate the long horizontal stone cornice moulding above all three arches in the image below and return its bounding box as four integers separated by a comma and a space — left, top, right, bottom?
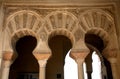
2, 1, 116, 7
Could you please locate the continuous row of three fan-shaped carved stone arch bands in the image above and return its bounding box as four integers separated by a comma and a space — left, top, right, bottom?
5, 9, 115, 53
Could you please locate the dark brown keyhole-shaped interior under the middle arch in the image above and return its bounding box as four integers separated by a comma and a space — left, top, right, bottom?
46, 35, 72, 79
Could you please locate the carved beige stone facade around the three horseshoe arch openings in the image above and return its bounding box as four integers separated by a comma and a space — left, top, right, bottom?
0, 0, 120, 79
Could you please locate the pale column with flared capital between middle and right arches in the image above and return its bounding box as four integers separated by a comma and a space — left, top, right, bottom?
70, 50, 89, 79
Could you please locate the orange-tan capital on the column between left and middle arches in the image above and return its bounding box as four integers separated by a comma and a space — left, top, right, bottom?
33, 52, 51, 60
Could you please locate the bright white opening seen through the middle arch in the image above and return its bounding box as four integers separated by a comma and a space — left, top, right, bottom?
64, 50, 78, 79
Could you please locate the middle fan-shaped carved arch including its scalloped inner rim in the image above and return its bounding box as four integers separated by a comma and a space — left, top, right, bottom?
43, 11, 78, 43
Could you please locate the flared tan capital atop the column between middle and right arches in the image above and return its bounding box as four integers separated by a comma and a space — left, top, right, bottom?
70, 49, 90, 60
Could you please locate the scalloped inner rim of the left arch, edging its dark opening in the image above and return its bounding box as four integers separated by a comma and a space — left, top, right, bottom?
10, 29, 39, 51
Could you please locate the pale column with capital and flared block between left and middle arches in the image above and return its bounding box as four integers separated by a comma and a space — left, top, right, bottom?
33, 39, 52, 79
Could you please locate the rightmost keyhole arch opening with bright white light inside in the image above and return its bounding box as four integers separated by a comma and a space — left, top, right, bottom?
85, 34, 113, 79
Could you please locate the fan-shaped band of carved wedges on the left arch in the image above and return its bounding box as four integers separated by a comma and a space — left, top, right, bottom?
4, 10, 43, 34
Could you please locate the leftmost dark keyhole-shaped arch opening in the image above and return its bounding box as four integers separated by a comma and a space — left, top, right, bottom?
9, 36, 39, 79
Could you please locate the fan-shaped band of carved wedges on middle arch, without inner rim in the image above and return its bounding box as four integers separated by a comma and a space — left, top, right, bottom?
45, 11, 78, 32
